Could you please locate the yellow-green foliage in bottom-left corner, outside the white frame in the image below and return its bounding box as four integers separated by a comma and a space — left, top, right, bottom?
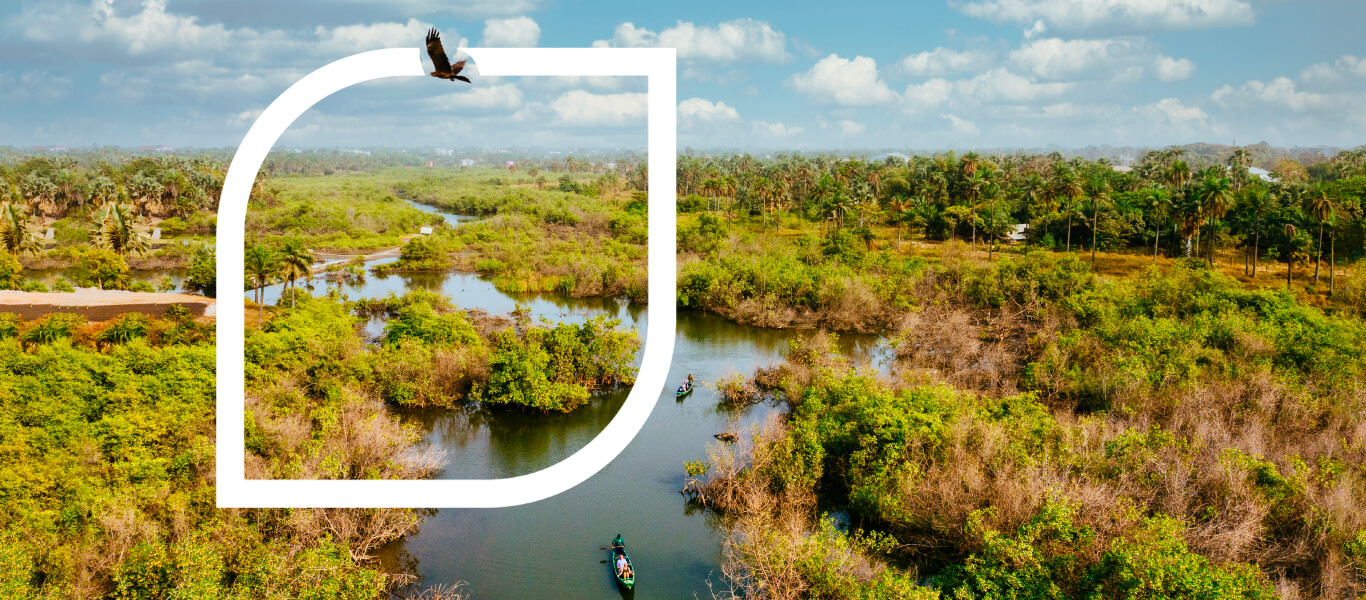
0, 330, 387, 600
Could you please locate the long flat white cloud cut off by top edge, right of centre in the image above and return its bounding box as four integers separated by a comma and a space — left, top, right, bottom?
951, 0, 1255, 33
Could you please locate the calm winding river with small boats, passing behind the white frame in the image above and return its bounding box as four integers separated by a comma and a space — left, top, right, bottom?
249, 200, 887, 600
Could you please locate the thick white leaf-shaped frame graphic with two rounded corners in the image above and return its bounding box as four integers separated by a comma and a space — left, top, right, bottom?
217, 48, 678, 508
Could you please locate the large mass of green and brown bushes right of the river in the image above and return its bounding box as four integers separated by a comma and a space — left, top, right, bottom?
706, 262, 1366, 600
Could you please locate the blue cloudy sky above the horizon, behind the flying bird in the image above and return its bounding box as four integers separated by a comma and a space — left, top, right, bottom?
0, 0, 1366, 150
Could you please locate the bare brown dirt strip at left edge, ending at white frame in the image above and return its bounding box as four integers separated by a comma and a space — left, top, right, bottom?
0, 287, 217, 321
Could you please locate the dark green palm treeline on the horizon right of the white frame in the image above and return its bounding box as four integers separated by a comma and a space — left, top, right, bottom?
678, 148, 1366, 279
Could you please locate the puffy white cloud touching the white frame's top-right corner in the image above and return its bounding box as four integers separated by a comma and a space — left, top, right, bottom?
593, 19, 791, 64
